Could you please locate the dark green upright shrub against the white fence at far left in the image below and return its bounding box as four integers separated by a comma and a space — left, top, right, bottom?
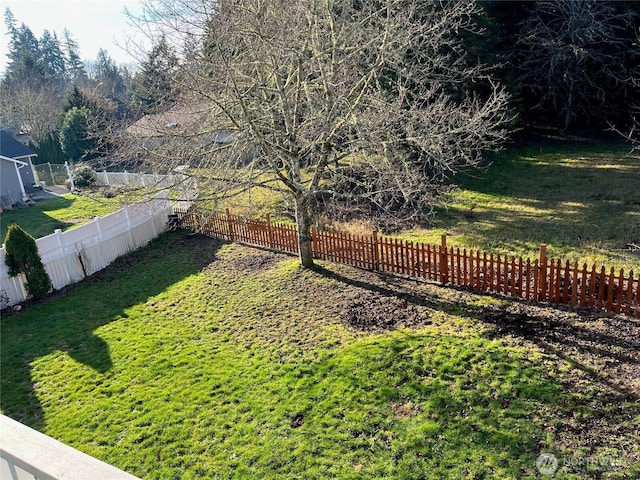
4, 223, 52, 298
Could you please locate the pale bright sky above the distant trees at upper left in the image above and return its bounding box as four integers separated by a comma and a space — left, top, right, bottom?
0, 0, 146, 71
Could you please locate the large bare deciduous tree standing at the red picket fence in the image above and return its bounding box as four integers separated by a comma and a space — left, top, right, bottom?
127, 0, 510, 266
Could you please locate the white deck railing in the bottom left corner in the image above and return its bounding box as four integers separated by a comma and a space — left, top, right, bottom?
0, 415, 139, 480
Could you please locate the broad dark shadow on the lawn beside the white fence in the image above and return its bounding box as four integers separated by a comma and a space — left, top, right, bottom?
0, 232, 221, 429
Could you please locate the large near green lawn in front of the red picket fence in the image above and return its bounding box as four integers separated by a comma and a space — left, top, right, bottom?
0, 233, 640, 479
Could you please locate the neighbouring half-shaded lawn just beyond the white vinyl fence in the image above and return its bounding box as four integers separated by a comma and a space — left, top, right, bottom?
0, 190, 144, 240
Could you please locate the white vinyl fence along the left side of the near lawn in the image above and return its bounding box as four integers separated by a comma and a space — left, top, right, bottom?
0, 191, 172, 305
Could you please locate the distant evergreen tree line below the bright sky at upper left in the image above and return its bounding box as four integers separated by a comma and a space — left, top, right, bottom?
0, 8, 170, 163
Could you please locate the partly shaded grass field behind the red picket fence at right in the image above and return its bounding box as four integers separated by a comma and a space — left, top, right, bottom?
404, 143, 640, 272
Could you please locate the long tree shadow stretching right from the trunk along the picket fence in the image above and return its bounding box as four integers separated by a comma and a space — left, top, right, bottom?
316, 267, 640, 399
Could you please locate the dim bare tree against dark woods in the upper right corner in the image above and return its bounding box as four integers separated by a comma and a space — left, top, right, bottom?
518, 0, 639, 130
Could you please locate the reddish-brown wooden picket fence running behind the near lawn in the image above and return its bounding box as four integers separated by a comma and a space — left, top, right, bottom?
176, 207, 640, 318
